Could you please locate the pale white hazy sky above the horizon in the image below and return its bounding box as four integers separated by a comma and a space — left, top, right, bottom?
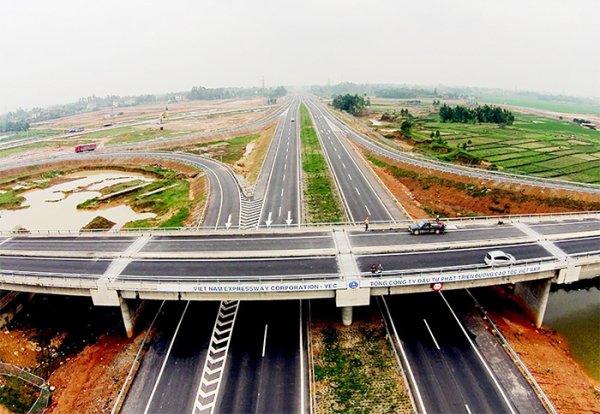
0, 0, 600, 113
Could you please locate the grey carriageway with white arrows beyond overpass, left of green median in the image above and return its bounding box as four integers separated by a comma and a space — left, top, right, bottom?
259, 99, 302, 227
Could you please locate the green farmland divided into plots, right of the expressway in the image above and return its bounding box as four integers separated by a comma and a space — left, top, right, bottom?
360, 101, 600, 184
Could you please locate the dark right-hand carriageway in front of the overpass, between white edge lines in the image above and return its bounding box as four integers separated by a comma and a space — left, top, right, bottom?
385, 293, 511, 414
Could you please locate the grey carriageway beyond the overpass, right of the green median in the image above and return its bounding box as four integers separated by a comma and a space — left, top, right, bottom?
303, 99, 406, 223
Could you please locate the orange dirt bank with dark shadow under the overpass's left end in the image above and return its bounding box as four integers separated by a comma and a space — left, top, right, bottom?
0, 295, 153, 414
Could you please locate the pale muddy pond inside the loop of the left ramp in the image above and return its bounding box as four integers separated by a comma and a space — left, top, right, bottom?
0, 171, 156, 230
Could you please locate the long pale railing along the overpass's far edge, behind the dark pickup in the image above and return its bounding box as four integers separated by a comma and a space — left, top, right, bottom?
0, 210, 600, 236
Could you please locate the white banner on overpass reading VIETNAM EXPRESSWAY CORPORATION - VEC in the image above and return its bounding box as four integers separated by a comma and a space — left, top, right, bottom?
157, 281, 346, 293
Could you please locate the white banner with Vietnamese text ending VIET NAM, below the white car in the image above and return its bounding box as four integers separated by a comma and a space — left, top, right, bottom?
360, 263, 556, 287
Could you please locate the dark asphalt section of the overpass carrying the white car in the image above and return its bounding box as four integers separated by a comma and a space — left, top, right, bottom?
357, 241, 552, 272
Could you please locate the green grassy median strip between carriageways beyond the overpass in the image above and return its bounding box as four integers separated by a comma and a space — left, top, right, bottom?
300, 104, 345, 223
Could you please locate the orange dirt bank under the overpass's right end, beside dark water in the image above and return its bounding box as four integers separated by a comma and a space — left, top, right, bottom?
478, 287, 600, 413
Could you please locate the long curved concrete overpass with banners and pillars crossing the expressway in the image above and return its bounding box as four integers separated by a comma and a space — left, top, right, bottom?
0, 212, 600, 333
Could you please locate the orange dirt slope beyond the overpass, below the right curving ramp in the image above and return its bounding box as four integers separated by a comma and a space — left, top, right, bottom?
363, 150, 600, 218
